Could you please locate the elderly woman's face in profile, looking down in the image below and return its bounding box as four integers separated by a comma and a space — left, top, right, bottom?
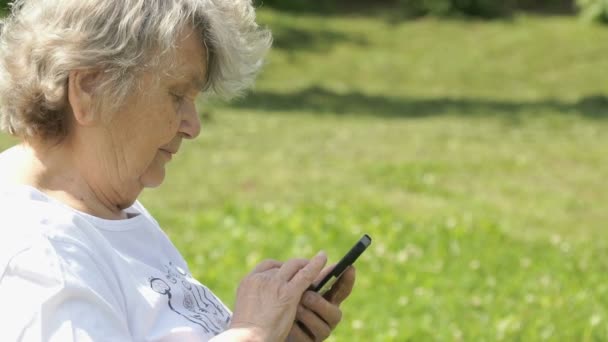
98, 29, 206, 187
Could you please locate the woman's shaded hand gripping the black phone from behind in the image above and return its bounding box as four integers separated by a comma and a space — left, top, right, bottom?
288, 266, 355, 342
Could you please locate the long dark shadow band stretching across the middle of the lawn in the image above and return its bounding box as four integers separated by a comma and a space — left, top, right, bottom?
230, 87, 608, 119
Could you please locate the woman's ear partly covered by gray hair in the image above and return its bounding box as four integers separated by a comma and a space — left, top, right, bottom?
68, 70, 101, 126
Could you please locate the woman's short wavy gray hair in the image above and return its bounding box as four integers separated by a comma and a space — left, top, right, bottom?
0, 0, 271, 139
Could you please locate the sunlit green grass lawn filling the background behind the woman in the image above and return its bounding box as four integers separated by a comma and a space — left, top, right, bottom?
0, 10, 608, 341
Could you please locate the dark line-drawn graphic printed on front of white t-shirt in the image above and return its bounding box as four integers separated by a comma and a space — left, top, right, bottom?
150, 263, 230, 335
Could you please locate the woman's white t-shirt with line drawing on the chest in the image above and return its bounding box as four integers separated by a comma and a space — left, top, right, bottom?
0, 185, 231, 342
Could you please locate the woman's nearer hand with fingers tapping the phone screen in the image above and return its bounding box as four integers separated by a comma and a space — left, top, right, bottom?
230, 252, 327, 341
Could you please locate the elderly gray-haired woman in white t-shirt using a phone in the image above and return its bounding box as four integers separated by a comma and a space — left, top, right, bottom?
0, 0, 354, 341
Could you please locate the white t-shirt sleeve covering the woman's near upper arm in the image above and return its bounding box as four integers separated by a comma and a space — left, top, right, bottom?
0, 238, 132, 342
